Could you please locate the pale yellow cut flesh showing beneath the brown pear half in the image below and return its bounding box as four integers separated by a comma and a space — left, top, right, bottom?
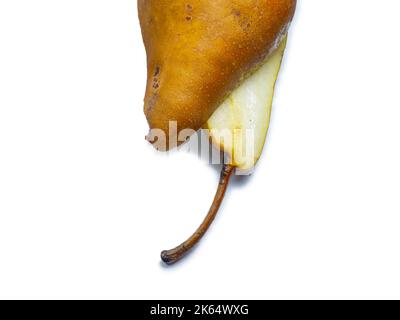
207, 37, 286, 170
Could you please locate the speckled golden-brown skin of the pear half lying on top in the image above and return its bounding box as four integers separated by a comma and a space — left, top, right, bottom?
138, 0, 296, 146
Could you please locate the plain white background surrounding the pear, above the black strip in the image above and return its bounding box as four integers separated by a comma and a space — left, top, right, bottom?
0, 0, 400, 299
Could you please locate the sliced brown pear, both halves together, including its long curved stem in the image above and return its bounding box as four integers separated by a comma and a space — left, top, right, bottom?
138, 0, 296, 264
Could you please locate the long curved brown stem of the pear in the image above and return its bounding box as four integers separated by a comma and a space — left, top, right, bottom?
161, 164, 234, 265
